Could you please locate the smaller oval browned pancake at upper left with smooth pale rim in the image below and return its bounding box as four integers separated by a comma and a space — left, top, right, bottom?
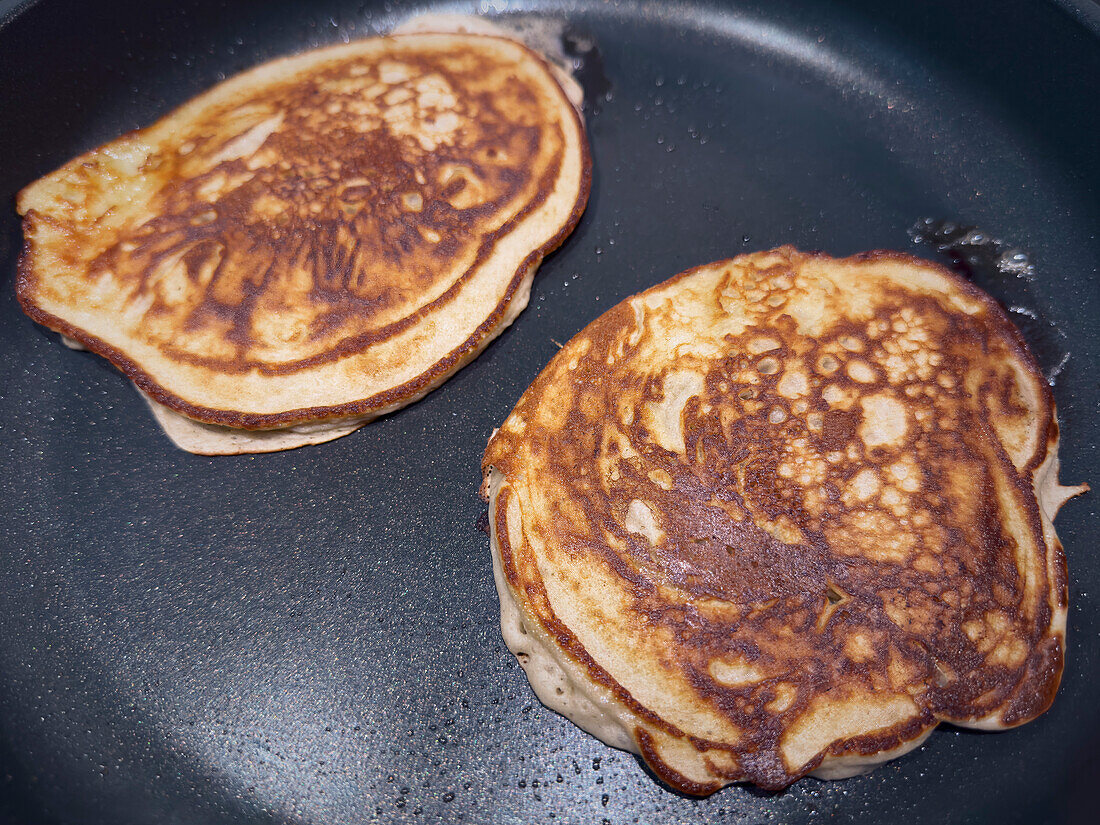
17, 32, 591, 452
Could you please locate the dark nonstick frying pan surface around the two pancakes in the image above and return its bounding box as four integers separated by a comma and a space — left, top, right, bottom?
0, 0, 1100, 825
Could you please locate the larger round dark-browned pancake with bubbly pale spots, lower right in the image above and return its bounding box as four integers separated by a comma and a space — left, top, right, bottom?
483, 246, 1085, 794
